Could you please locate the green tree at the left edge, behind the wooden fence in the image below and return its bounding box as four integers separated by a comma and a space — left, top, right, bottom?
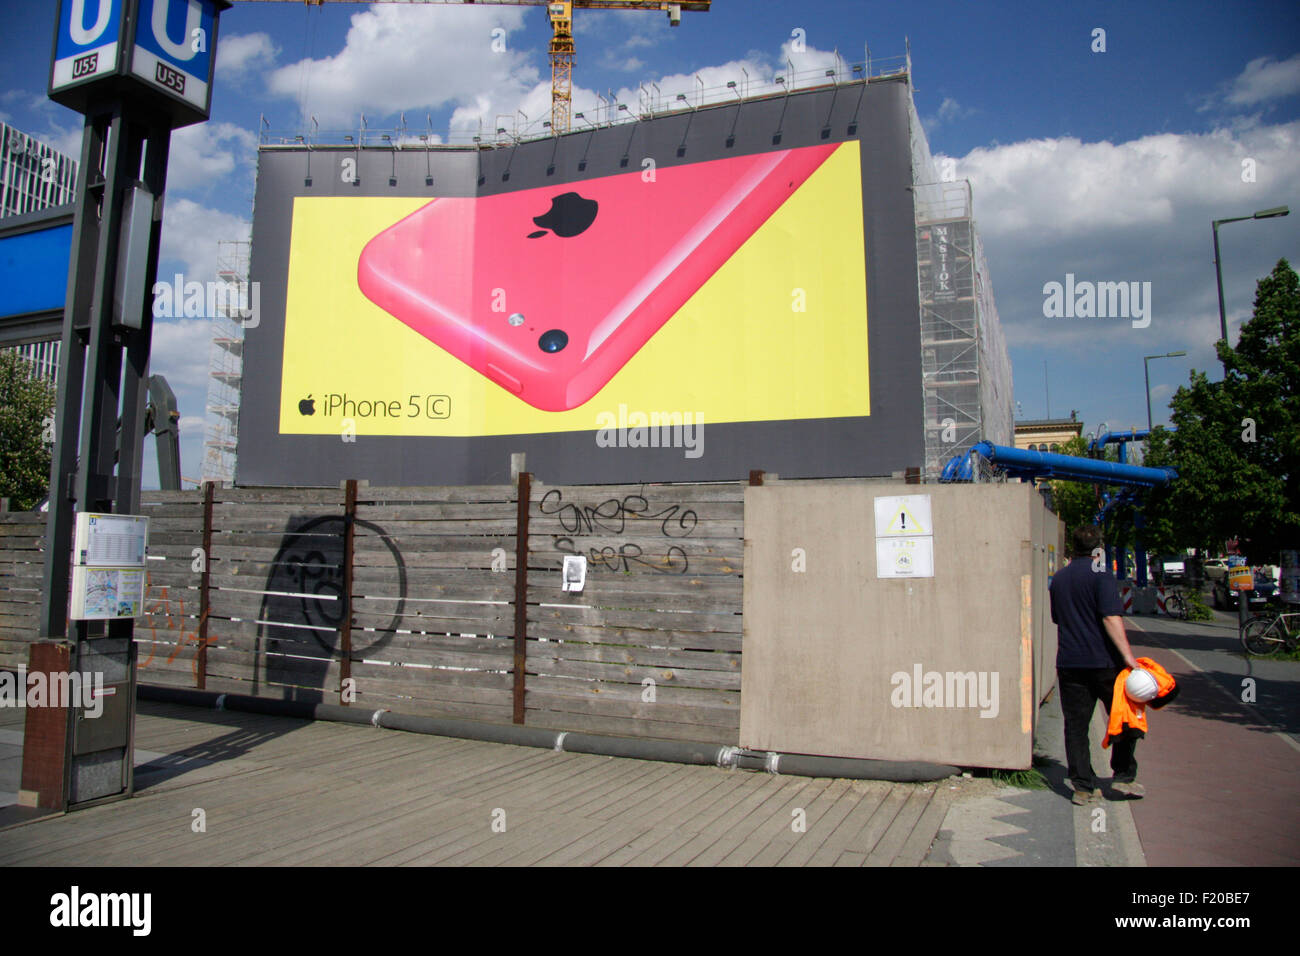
0, 350, 55, 511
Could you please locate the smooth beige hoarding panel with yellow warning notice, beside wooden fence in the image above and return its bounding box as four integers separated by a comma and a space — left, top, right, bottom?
740, 481, 1060, 767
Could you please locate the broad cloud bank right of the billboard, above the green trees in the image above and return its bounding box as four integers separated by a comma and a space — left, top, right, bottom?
957, 122, 1300, 361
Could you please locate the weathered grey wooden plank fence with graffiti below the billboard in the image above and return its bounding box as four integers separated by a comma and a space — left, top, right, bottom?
0, 476, 744, 743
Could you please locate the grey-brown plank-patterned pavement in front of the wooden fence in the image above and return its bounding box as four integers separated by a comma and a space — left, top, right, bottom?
0, 701, 961, 866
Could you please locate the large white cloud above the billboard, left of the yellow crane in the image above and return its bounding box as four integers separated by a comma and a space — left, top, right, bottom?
268, 5, 540, 127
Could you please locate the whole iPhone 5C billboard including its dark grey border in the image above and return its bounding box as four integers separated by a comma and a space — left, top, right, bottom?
238, 81, 923, 485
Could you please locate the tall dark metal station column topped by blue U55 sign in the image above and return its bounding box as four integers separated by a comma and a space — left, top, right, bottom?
18, 0, 230, 810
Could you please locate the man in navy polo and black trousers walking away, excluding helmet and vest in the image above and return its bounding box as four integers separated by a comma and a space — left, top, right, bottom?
1048, 524, 1144, 805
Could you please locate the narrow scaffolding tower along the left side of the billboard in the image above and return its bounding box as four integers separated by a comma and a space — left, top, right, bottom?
203, 239, 251, 484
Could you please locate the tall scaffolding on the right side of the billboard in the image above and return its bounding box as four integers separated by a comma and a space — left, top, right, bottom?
915, 179, 1013, 479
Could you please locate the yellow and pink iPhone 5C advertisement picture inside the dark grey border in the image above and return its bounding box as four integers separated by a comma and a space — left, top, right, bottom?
280, 142, 871, 436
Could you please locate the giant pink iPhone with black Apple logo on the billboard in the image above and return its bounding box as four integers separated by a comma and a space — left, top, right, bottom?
358, 143, 836, 411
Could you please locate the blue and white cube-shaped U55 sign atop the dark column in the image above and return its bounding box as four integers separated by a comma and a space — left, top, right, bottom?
49, 0, 230, 126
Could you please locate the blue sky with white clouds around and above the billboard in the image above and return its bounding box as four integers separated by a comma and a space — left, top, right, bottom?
0, 0, 1300, 476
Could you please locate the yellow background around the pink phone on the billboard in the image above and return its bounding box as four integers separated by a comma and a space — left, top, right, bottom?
280, 142, 870, 436
